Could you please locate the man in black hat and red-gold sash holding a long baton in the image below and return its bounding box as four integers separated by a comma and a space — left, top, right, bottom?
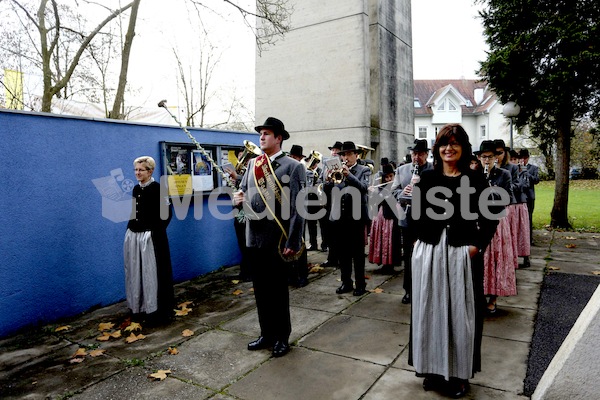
234, 117, 306, 357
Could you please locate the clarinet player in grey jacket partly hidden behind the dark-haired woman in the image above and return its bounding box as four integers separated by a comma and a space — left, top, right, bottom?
391, 139, 433, 304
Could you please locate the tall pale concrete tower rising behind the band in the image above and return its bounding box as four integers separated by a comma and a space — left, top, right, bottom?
256, 0, 414, 166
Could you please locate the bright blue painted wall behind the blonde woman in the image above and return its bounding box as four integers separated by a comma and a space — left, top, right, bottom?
0, 110, 258, 337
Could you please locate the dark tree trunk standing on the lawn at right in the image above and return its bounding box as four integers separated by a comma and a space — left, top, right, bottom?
550, 117, 571, 229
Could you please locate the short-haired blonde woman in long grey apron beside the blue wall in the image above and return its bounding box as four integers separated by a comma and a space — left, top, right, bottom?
123, 156, 175, 326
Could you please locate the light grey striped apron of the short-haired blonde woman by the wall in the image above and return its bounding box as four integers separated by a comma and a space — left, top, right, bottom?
123, 229, 158, 314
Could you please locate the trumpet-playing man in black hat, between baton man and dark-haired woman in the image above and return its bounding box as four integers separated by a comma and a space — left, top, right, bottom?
324, 142, 371, 296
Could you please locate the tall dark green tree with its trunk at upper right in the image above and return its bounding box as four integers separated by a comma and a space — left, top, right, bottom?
475, 0, 600, 228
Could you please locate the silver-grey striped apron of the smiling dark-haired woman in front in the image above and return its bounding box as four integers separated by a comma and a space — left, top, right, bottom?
411, 230, 476, 379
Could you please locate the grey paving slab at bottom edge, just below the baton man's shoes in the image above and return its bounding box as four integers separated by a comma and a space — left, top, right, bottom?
227, 347, 385, 400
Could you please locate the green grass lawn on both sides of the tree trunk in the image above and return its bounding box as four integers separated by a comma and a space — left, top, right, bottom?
533, 179, 600, 232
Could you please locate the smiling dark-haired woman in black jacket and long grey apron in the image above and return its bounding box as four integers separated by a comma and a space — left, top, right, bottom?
409, 124, 501, 398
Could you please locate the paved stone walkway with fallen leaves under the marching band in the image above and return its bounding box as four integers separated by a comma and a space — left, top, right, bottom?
0, 231, 599, 400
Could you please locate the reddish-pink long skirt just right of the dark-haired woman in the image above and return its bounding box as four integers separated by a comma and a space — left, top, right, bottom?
483, 216, 517, 296
